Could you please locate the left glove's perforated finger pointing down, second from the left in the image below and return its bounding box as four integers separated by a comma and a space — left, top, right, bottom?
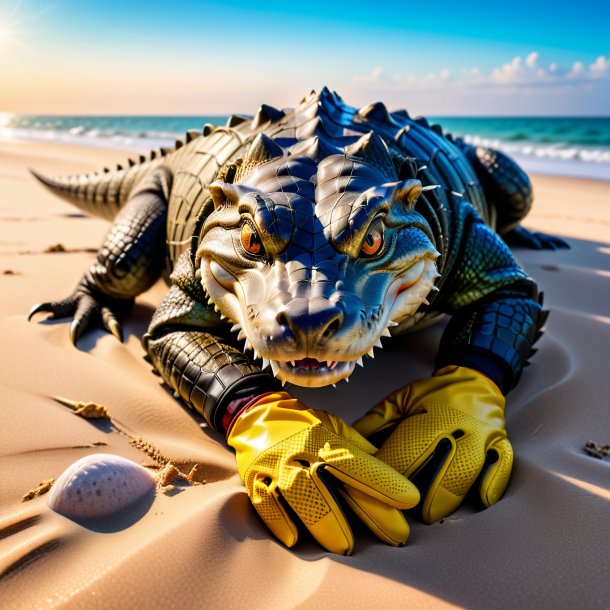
281, 462, 354, 555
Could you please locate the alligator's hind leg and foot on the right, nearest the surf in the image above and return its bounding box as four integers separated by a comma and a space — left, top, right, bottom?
458, 142, 570, 250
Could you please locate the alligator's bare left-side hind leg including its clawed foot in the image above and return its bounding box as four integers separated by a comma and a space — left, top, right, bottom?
28, 169, 167, 345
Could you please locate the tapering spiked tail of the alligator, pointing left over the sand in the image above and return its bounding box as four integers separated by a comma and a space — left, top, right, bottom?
30, 152, 163, 220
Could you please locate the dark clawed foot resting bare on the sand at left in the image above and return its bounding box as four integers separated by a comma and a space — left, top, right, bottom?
28, 278, 133, 345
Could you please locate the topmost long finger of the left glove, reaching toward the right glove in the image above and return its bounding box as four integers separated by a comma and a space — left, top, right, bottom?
319, 446, 419, 509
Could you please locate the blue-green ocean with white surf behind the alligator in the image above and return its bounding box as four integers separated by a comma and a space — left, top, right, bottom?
0, 114, 610, 180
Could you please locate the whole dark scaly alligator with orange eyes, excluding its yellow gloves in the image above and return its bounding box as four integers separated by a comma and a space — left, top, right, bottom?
30, 88, 565, 540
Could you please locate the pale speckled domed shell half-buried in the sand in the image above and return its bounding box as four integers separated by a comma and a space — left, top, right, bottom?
48, 453, 155, 520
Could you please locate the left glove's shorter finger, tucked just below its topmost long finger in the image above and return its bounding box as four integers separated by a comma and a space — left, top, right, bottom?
339, 487, 410, 546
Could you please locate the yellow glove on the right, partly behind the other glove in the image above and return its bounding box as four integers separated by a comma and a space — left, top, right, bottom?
354, 366, 513, 523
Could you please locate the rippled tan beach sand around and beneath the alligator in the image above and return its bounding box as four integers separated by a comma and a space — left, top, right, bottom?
0, 142, 610, 609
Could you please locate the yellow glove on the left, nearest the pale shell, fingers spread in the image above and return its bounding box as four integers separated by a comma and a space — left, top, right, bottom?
227, 392, 419, 555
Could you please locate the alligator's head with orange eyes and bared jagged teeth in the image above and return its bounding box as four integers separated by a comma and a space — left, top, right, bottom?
196, 133, 438, 387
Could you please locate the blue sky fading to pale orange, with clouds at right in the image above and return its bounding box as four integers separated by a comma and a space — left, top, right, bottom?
0, 0, 610, 116
